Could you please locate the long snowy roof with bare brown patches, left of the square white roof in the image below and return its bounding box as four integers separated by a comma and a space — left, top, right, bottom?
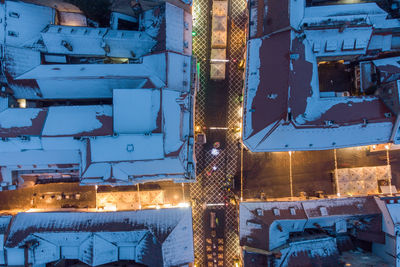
0, 106, 113, 137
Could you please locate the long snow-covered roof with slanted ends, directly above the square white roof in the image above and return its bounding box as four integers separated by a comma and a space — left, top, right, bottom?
11, 64, 165, 99
